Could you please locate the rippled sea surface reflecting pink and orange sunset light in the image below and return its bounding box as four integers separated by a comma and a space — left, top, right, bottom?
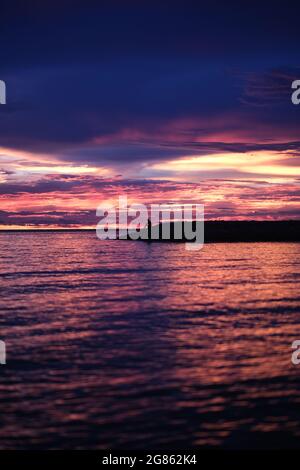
0, 232, 300, 449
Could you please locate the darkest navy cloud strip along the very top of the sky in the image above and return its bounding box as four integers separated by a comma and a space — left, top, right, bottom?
0, 0, 299, 70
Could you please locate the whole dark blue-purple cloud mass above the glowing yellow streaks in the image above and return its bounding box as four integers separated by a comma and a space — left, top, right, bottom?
0, 1, 300, 162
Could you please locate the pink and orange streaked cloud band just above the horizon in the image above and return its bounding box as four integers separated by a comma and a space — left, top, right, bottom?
0, 175, 300, 229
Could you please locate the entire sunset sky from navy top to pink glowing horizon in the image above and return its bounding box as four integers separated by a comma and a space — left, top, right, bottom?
0, 0, 300, 229
